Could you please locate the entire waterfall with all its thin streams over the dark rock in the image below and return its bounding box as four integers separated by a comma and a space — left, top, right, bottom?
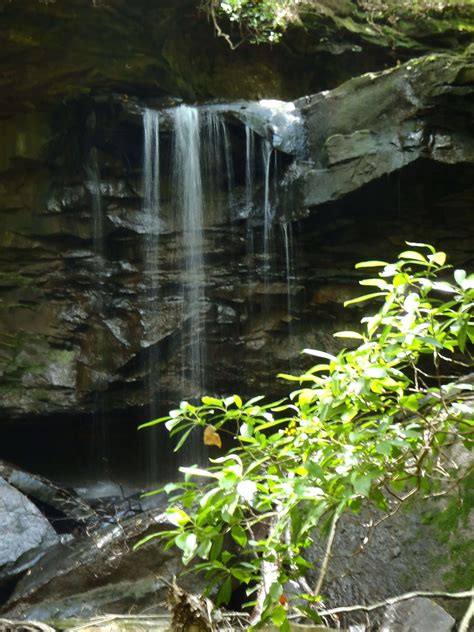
143, 100, 300, 478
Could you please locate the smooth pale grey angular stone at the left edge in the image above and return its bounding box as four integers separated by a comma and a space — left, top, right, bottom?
0, 478, 58, 582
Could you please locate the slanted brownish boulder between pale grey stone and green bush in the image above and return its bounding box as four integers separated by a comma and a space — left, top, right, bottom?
4, 511, 187, 620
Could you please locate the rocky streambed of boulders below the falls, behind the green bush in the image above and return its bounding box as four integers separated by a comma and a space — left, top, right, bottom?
0, 462, 470, 632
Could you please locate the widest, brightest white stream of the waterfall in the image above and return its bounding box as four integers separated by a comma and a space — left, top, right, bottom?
173, 105, 205, 395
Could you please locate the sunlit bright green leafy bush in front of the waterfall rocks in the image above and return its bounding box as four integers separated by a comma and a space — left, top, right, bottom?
136, 244, 474, 630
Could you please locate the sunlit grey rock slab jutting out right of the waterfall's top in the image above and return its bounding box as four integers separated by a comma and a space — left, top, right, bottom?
286, 47, 474, 212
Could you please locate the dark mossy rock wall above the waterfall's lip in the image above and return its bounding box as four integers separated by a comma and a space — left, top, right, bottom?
0, 0, 472, 115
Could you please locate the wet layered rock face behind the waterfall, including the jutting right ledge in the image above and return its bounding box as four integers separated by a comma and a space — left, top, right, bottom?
0, 50, 472, 418
